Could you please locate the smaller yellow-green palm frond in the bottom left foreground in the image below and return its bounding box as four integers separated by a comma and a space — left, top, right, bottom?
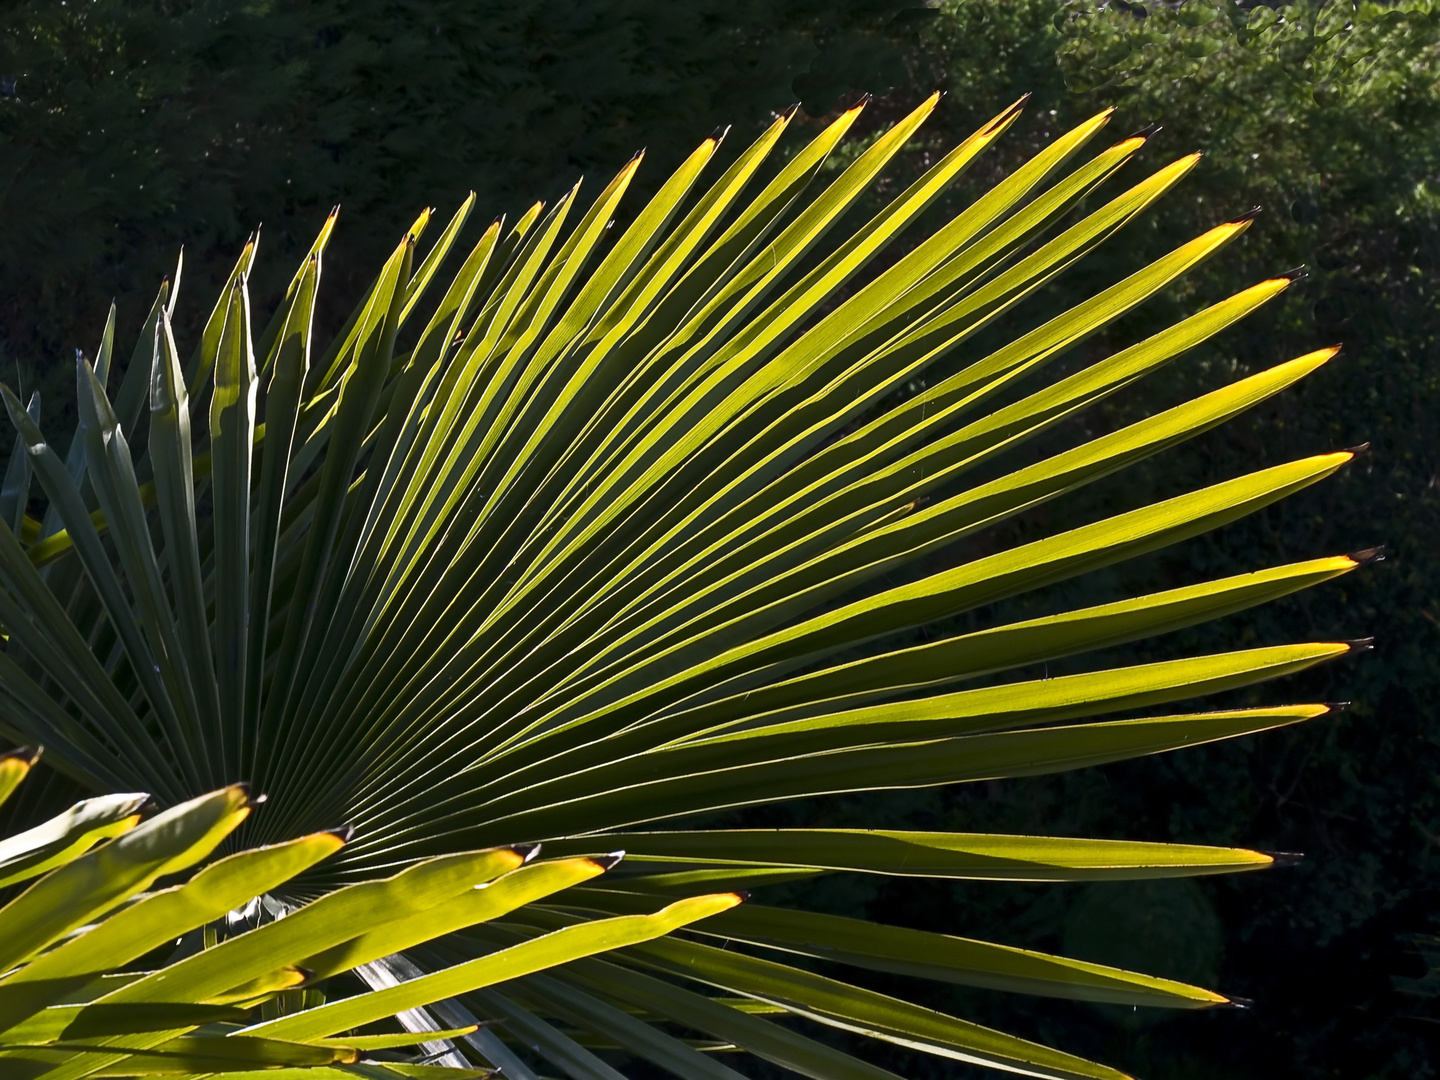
0, 752, 720, 1080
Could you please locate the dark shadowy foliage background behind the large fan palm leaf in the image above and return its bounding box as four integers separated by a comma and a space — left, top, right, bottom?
0, 0, 1440, 1080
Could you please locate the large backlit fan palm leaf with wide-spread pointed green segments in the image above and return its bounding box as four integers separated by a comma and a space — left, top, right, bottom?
0, 99, 1365, 1080
